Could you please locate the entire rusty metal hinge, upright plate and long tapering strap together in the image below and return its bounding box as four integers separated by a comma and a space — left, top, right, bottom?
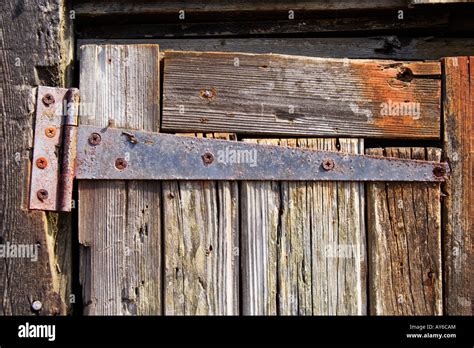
30, 87, 450, 211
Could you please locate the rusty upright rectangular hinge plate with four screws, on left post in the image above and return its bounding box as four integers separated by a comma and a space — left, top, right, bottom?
29, 86, 79, 211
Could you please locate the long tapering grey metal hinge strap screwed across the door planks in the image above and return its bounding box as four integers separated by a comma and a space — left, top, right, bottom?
76, 125, 449, 182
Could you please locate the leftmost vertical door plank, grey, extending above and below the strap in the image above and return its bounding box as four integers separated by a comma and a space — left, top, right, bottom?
78, 45, 162, 315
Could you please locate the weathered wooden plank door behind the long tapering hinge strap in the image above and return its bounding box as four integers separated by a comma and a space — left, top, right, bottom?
78, 45, 472, 315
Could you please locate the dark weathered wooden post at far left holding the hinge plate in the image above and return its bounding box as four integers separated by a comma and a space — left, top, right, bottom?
0, 0, 73, 315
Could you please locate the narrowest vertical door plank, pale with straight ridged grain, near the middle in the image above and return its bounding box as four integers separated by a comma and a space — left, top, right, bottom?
240, 139, 280, 315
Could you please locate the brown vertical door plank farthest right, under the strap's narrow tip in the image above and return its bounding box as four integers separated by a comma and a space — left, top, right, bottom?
366, 148, 443, 315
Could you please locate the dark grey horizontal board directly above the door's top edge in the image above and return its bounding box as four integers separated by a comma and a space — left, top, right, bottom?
77, 35, 474, 60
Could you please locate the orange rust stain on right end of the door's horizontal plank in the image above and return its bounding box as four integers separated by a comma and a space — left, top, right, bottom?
350, 62, 441, 136
